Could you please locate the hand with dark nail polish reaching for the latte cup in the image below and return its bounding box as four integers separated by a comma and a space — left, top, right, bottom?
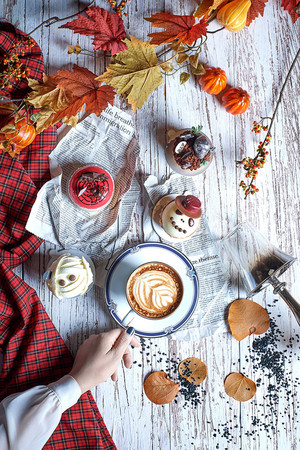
69, 327, 140, 393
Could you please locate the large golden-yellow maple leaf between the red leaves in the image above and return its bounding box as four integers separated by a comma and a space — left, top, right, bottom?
97, 36, 163, 112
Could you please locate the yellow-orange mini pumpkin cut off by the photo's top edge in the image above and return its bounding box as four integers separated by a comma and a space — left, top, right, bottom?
217, 0, 251, 32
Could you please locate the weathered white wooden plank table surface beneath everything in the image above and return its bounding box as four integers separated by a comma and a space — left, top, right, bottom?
0, 0, 300, 450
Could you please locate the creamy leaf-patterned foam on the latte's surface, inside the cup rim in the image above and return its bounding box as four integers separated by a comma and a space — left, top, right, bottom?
132, 270, 179, 314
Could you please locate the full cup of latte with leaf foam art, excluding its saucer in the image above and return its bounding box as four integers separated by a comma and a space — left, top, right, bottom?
126, 262, 183, 319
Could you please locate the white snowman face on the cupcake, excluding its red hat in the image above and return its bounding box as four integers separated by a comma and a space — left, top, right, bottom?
161, 200, 200, 239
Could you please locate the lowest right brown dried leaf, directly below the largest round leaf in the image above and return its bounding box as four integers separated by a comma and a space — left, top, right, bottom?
224, 372, 256, 402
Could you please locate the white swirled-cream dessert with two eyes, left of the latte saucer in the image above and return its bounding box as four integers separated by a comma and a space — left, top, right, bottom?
47, 253, 93, 299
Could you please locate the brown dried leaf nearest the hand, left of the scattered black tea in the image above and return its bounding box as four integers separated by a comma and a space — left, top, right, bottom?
144, 370, 179, 405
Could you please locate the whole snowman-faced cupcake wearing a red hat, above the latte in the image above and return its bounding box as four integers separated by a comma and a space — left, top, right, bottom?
160, 195, 202, 239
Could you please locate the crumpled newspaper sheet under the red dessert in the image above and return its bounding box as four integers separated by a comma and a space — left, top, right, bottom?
26, 106, 140, 286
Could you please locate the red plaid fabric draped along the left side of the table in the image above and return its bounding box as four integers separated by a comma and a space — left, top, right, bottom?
0, 22, 116, 450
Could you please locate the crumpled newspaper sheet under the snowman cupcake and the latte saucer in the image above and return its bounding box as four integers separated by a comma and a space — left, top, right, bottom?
143, 174, 235, 340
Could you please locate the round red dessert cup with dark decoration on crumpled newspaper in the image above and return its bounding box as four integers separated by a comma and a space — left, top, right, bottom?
68, 165, 114, 210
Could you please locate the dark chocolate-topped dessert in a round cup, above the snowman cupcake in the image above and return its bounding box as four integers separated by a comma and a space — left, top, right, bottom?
166, 126, 215, 176
